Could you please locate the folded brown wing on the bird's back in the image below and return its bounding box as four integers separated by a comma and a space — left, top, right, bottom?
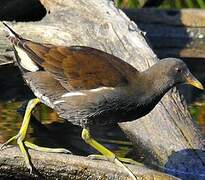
26, 41, 138, 90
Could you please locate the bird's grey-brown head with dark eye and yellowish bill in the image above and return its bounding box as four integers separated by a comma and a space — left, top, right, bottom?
157, 58, 204, 90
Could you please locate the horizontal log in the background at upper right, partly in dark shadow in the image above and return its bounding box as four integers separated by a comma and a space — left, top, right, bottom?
0, 8, 205, 65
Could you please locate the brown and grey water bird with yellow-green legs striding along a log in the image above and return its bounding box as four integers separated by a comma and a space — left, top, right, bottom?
1, 23, 203, 179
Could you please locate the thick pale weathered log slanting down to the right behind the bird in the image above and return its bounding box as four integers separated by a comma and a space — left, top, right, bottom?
0, 0, 205, 179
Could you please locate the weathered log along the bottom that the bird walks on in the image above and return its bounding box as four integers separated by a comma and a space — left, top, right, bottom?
0, 147, 177, 180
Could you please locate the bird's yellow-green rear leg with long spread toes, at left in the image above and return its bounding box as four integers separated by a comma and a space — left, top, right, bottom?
0, 99, 71, 173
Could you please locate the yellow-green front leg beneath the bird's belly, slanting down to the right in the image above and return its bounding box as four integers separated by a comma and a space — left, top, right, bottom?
82, 129, 137, 180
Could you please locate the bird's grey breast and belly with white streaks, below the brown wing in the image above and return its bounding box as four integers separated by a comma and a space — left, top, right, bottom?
47, 87, 163, 127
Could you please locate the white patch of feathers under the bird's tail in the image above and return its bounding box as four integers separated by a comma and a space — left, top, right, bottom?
15, 46, 39, 72
